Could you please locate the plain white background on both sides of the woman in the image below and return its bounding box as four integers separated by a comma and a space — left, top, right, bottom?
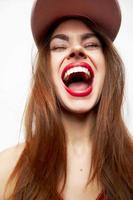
0, 0, 133, 151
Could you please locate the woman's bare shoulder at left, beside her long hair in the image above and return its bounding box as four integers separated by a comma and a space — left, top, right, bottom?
0, 143, 25, 199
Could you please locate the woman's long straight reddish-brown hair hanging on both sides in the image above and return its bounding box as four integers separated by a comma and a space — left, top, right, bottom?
4, 18, 133, 200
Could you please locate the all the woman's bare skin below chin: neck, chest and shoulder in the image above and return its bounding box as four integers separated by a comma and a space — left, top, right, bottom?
0, 111, 102, 200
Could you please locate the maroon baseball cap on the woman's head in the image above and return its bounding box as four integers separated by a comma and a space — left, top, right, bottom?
31, 0, 121, 45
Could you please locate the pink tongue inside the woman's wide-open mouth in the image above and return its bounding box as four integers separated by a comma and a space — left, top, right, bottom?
68, 82, 88, 91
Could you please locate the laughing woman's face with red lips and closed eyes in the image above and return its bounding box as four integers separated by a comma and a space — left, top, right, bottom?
50, 19, 105, 113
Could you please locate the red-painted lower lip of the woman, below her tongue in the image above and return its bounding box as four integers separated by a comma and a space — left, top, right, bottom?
64, 85, 93, 97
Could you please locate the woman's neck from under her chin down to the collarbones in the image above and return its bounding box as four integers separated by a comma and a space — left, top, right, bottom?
62, 108, 95, 147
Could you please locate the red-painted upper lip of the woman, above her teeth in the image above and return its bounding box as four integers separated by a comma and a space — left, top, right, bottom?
61, 62, 94, 79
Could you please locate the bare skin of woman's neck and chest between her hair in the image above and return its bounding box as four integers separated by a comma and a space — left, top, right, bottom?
57, 113, 102, 200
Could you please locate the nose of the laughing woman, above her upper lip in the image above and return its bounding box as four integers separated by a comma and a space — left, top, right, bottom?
68, 47, 87, 59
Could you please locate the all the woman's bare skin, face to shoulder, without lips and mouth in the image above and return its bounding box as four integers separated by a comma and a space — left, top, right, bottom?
0, 20, 105, 200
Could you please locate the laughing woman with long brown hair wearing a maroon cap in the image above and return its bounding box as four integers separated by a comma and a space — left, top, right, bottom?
1, 0, 133, 200
